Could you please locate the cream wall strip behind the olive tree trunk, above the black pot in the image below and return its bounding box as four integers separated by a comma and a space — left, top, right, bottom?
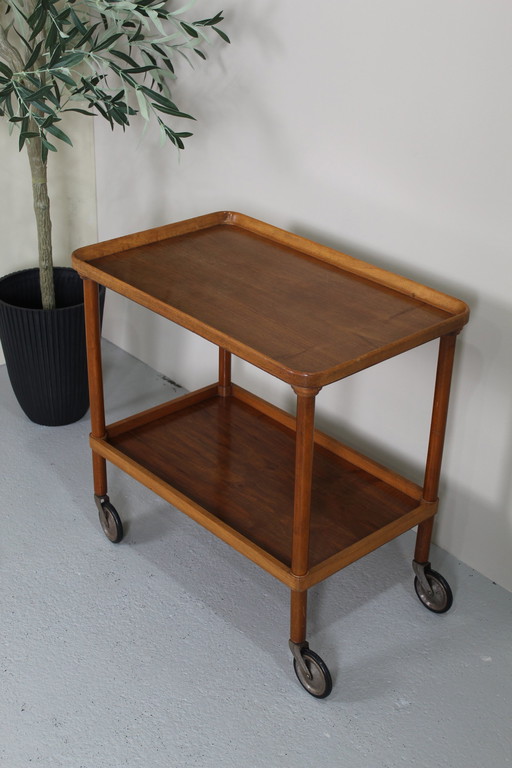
0, 114, 97, 364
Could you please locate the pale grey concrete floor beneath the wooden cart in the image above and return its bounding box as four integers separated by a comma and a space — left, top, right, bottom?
0, 344, 512, 768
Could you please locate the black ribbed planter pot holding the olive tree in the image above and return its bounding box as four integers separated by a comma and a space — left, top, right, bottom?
0, 267, 105, 427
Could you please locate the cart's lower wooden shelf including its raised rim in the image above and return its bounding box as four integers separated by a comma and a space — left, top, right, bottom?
91, 385, 436, 590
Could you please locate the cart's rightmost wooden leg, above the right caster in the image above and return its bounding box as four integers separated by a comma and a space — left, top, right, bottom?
414, 334, 457, 563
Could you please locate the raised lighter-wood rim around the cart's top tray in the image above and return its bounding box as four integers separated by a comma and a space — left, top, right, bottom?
72, 211, 469, 387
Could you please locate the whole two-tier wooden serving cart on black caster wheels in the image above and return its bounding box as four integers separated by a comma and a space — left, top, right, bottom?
73, 212, 469, 698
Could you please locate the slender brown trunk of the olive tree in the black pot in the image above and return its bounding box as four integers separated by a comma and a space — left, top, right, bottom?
25, 134, 55, 309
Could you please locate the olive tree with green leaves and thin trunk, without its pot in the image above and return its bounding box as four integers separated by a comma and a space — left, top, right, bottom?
0, 0, 229, 309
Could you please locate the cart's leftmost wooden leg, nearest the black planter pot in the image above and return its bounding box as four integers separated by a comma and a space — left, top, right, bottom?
84, 278, 107, 496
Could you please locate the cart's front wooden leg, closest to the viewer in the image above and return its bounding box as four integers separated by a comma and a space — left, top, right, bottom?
290, 387, 320, 643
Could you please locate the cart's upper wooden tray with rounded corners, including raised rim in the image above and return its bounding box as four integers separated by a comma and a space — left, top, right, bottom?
73, 212, 469, 387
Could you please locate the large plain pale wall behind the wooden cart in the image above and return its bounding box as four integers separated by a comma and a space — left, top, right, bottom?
92, 0, 512, 589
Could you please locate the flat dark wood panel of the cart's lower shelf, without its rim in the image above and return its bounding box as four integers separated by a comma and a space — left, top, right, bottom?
107, 397, 426, 568
